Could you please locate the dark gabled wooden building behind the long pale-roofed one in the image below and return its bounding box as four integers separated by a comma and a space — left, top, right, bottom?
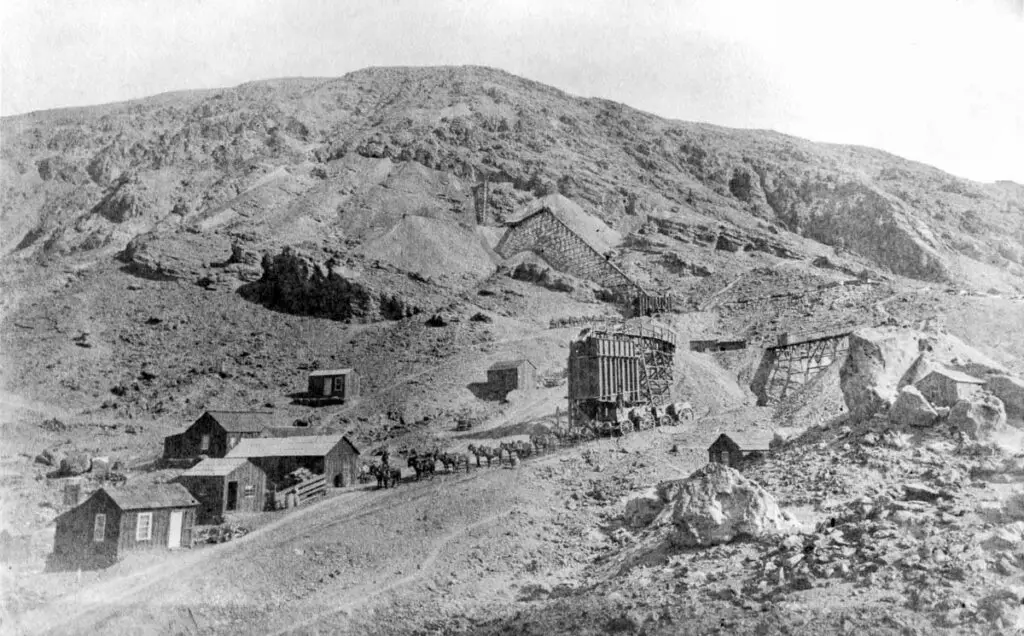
164, 411, 274, 459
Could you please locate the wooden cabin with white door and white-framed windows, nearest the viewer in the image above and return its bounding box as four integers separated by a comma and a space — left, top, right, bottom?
52, 483, 199, 568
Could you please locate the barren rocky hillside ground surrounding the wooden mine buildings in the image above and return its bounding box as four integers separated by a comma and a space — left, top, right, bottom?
0, 67, 1024, 634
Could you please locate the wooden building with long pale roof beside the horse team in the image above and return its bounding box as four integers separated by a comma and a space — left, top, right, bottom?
227, 434, 359, 487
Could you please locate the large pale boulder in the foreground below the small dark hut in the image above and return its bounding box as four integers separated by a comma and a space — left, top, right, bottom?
669, 463, 790, 547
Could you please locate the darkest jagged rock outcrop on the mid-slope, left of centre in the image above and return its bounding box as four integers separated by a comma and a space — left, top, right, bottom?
242, 248, 426, 322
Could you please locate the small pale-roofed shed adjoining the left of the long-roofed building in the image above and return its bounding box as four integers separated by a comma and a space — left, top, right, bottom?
178, 457, 266, 523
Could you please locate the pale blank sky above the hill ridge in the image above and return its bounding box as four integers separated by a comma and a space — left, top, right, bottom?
0, 0, 1024, 183
